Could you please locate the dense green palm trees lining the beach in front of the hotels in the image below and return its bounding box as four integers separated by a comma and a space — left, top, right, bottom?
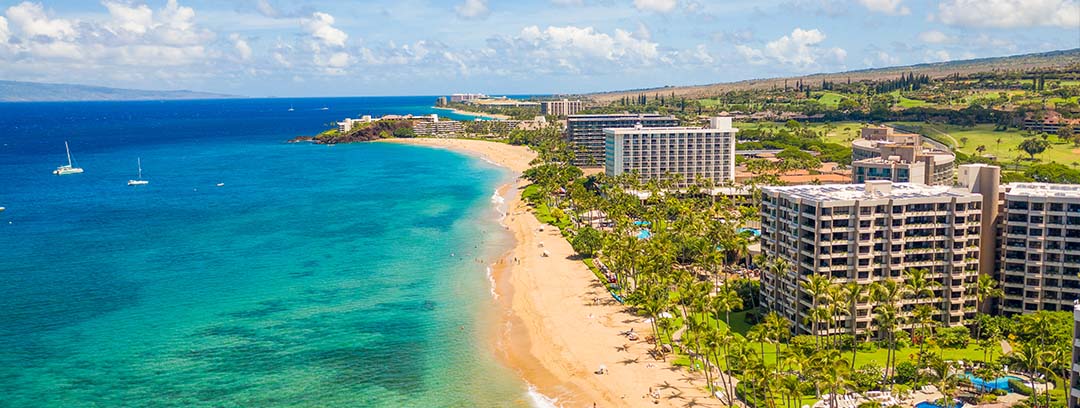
525, 131, 1071, 408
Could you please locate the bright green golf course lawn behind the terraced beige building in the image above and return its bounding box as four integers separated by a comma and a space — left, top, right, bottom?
892, 122, 1080, 167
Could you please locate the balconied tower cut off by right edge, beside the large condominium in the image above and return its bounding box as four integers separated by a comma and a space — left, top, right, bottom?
998, 182, 1080, 315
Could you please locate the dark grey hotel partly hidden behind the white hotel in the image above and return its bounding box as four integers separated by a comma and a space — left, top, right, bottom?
566, 113, 678, 167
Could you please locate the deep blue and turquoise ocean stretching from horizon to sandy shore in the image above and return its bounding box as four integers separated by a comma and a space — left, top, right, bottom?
0, 97, 529, 407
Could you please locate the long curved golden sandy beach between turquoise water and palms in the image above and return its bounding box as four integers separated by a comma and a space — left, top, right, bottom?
387, 138, 723, 408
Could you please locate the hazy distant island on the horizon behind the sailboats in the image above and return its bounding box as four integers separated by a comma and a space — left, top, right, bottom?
0, 81, 240, 101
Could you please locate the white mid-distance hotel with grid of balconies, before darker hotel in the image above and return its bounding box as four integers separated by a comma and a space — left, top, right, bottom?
604, 118, 739, 187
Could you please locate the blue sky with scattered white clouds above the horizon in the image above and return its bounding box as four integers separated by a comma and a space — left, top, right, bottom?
0, 0, 1080, 96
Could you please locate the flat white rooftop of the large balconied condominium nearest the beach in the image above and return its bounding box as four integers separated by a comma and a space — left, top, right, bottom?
761, 181, 982, 202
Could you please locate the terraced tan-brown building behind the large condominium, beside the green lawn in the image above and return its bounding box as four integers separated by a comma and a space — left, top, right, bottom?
851, 126, 956, 186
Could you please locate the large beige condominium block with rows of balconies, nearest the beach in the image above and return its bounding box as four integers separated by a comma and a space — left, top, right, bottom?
761, 166, 999, 335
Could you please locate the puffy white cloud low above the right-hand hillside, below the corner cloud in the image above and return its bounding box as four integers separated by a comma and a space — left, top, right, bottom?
735, 28, 848, 69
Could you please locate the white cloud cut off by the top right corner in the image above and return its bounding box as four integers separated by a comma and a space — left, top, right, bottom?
937, 0, 1080, 29
